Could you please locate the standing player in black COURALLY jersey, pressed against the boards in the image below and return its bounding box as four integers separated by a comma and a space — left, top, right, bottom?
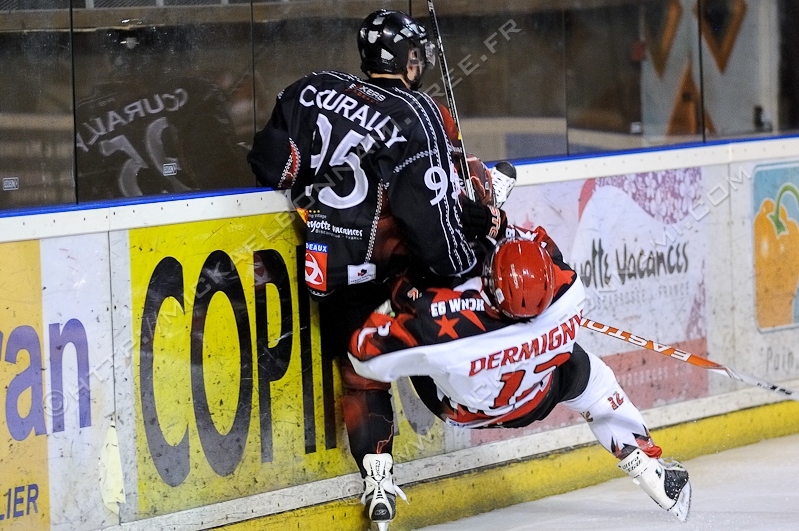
248, 10, 507, 531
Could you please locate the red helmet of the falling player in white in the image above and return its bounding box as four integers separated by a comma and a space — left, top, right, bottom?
484, 239, 555, 318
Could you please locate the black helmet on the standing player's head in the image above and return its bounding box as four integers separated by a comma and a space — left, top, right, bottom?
358, 9, 435, 79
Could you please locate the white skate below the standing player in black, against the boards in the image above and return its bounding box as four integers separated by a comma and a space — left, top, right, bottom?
361, 454, 408, 531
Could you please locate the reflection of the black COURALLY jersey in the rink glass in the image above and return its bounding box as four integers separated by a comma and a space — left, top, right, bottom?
75, 77, 255, 201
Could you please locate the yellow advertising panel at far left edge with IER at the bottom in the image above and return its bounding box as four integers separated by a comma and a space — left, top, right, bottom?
0, 241, 50, 530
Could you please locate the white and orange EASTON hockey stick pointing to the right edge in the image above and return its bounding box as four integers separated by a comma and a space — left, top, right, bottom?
580, 318, 799, 402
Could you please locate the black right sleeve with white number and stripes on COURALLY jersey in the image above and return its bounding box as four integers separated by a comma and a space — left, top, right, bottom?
388, 99, 476, 276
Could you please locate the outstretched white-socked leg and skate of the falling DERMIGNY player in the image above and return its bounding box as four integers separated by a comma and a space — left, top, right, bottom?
563, 344, 691, 521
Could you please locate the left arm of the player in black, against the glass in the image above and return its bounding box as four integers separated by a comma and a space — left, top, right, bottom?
247, 80, 302, 188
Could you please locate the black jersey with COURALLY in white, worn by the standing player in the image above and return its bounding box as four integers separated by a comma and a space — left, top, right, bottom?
248, 72, 476, 296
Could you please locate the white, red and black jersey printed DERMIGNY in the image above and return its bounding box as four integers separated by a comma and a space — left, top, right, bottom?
350, 274, 585, 427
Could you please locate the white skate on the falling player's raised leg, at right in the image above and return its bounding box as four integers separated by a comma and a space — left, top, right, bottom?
616, 448, 691, 522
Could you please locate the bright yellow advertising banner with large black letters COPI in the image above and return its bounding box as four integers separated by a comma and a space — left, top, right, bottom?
129, 213, 356, 517
